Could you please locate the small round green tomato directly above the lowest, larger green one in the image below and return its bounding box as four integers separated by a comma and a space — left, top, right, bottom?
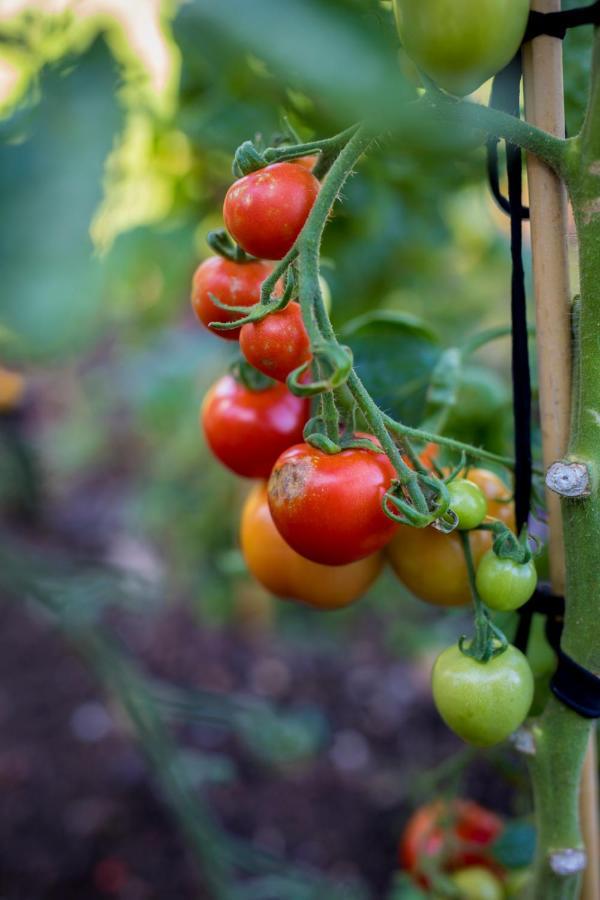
475, 550, 537, 612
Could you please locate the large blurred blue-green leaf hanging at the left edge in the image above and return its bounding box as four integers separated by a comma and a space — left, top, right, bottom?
0, 45, 119, 357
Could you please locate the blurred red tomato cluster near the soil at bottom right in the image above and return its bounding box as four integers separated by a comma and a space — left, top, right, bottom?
398, 798, 528, 900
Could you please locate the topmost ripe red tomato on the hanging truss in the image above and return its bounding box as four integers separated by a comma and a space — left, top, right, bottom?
223, 162, 320, 259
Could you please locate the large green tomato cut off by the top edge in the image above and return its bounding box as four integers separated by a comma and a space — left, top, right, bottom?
394, 0, 529, 96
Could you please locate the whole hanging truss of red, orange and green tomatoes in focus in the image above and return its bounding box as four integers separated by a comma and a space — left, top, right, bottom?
192, 149, 536, 746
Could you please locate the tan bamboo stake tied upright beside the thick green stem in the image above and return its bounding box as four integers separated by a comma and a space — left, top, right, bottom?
523, 0, 600, 900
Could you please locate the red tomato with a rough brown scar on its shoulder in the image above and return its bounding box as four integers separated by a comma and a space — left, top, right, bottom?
269, 435, 397, 566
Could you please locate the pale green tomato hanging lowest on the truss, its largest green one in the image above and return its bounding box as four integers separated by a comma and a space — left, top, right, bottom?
432, 645, 533, 747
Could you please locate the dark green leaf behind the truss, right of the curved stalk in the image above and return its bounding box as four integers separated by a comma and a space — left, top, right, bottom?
342, 311, 442, 425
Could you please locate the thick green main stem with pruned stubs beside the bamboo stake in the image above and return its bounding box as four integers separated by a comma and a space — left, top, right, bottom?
531, 21, 600, 900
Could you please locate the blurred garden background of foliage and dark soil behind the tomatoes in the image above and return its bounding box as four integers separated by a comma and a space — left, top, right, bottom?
0, 0, 590, 900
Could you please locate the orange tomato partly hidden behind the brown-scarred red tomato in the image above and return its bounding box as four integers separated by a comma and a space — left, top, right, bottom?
240, 482, 383, 609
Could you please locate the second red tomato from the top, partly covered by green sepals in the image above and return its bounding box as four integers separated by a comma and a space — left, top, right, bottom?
192, 256, 273, 341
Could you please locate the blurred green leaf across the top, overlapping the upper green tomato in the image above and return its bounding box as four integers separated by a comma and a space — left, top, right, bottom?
177, 0, 414, 127
